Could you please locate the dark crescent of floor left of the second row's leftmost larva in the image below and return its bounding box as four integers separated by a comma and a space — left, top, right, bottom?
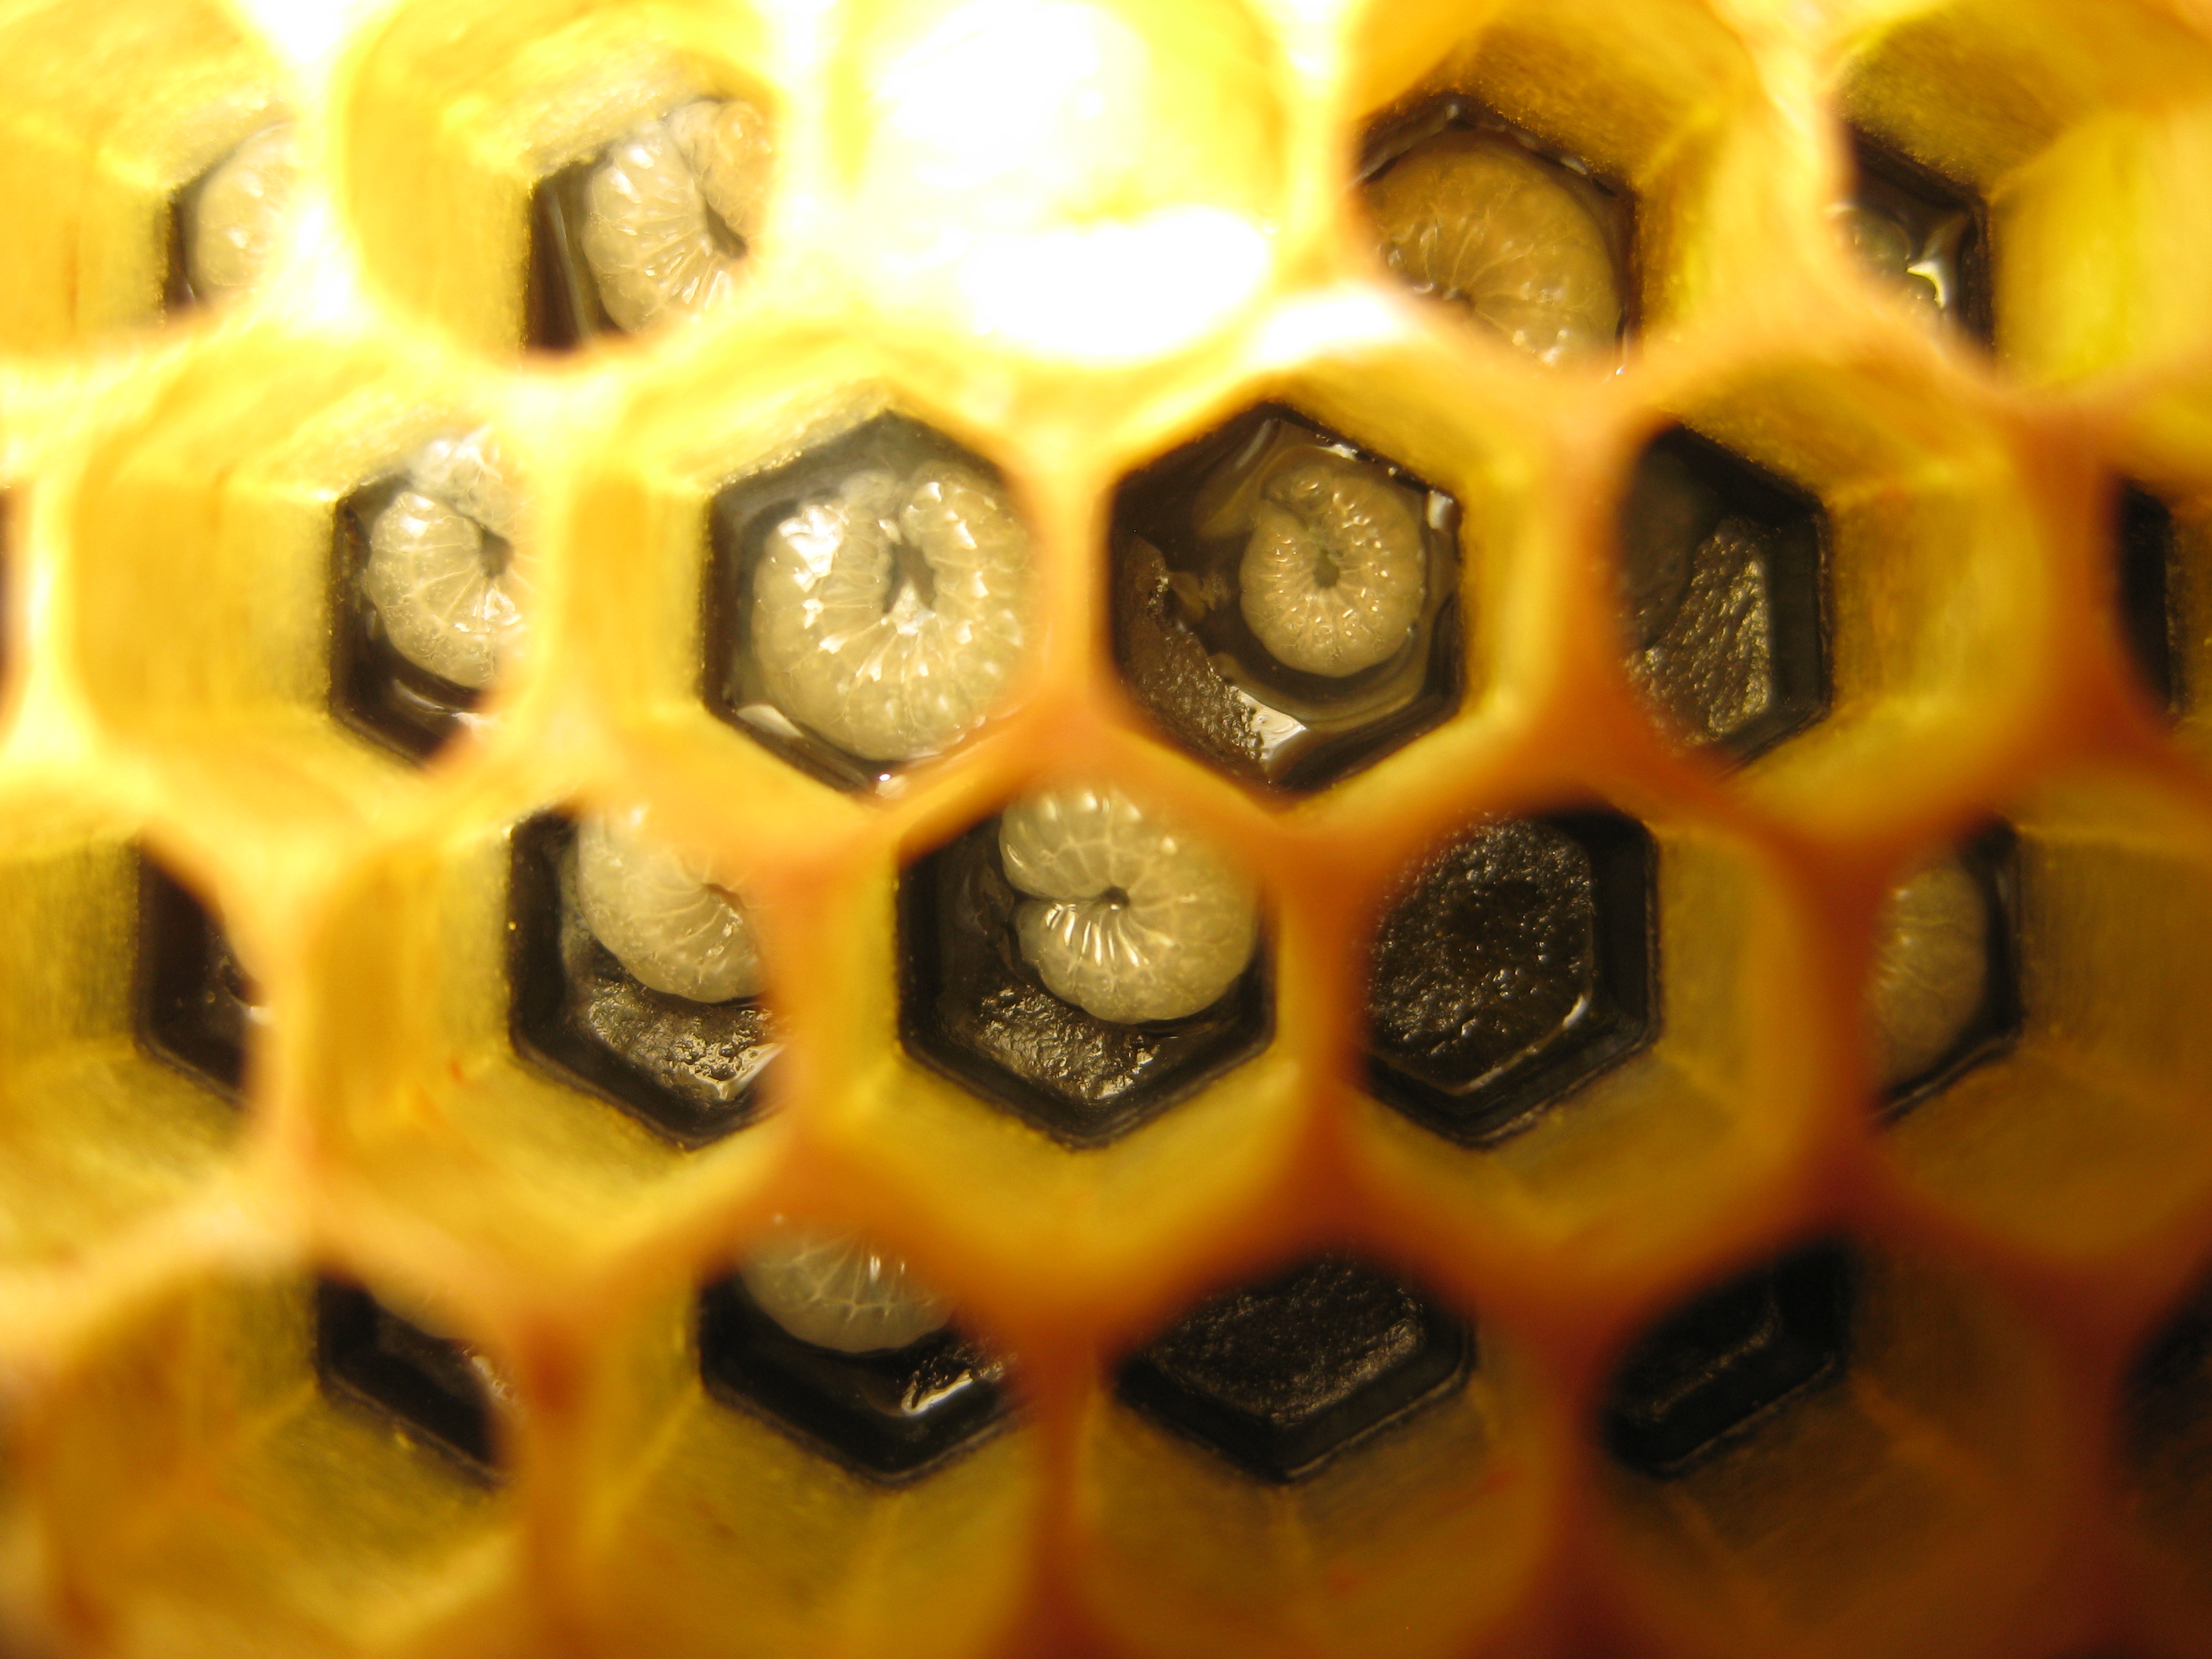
329, 478, 489, 761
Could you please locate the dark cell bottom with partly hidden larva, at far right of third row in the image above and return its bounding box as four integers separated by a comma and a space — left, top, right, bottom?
1869, 823, 2022, 1117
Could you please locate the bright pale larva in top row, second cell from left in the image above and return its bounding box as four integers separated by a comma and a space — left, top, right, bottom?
581, 100, 774, 329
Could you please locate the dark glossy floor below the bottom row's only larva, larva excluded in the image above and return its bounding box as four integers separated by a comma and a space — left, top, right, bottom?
699, 1276, 1006, 1480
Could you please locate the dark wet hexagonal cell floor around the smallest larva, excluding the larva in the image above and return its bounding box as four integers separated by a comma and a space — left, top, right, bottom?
1113, 403, 1462, 790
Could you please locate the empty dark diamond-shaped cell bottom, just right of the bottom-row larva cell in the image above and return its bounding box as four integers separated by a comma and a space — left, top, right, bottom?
1120, 1256, 1475, 1482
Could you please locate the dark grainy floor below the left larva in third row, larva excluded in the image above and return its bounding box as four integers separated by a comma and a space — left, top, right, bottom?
509, 814, 783, 1146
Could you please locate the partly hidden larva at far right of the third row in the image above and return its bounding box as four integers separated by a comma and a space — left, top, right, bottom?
1869, 856, 1991, 1088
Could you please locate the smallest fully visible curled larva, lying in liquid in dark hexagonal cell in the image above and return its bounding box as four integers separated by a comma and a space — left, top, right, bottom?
1237, 451, 1429, 677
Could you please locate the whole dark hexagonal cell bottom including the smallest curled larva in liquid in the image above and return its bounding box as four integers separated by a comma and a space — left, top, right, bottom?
1113, 403, 1462, 790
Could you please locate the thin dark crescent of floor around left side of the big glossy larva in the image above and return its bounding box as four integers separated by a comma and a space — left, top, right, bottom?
701, 413, 1004, 790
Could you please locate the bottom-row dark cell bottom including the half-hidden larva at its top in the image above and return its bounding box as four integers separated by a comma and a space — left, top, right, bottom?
699, 1239, 1006, 1480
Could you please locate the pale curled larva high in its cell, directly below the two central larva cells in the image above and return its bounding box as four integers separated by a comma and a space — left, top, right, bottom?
998, 787, 1258, 1024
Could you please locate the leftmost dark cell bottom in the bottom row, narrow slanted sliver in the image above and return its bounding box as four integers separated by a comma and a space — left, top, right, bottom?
314, 1279, 495, 1480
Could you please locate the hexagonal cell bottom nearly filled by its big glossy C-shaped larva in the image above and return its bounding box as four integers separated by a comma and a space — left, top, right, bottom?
701, 413, 1033, 790
